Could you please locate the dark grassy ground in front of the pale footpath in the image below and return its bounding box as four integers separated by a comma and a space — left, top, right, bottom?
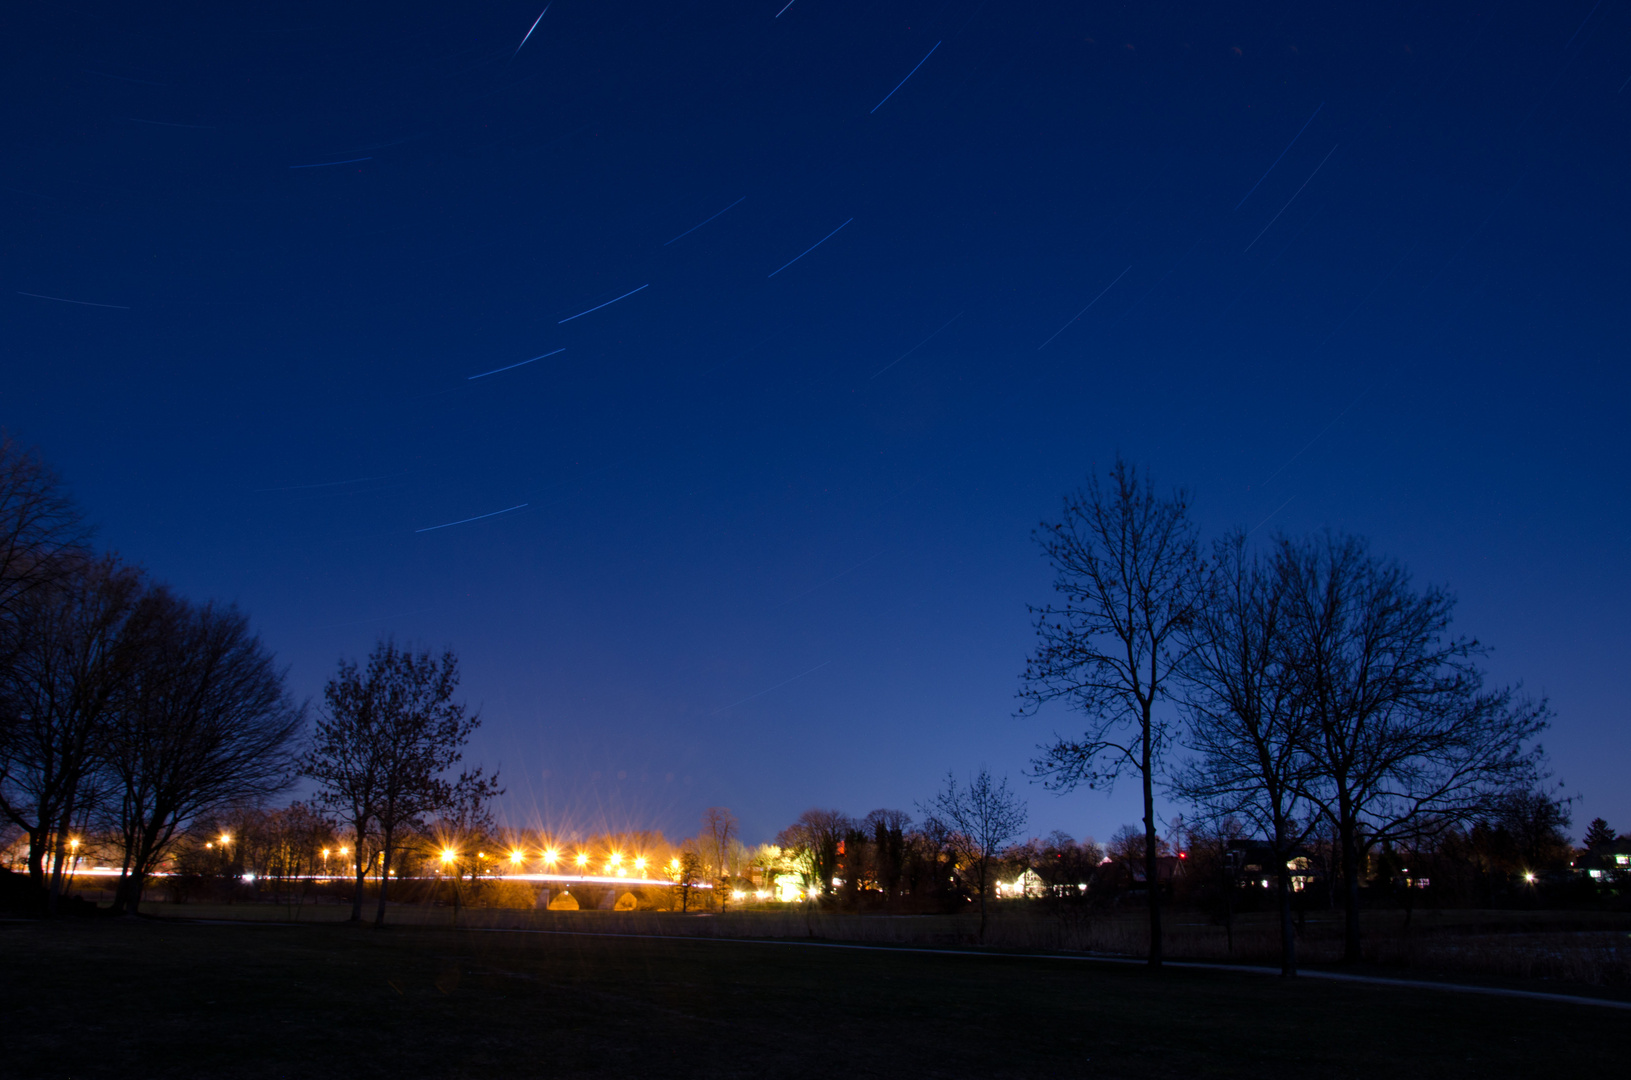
0, 920, 1631, 1080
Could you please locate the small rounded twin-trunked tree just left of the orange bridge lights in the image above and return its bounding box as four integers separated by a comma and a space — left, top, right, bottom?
302, 640, 502, 927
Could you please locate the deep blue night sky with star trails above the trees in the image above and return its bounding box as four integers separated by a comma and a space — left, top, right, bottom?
0, 0, 1631, 840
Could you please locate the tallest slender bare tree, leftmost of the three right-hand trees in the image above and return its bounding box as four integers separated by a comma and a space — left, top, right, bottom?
1019, 457, 1202, 966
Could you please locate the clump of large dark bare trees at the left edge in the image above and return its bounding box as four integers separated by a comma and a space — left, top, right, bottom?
0, 436, 303, 912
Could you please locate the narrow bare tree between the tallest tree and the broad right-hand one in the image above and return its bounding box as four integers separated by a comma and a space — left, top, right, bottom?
1173, 532, 1319, 976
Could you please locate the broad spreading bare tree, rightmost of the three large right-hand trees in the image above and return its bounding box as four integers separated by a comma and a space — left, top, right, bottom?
1275, 533, 1548, 961
